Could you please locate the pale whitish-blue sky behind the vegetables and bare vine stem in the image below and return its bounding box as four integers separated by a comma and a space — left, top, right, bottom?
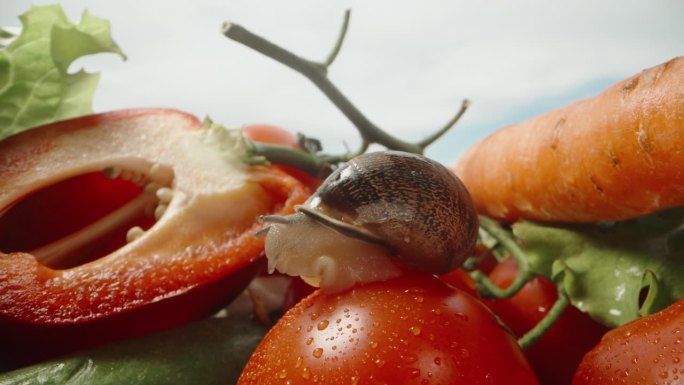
0, 0, 684, 165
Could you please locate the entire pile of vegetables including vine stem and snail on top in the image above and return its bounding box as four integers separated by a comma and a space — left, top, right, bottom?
0, 6, 684, 385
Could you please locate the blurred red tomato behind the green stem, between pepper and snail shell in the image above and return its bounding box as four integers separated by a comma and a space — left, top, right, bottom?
242, 124, 322, 191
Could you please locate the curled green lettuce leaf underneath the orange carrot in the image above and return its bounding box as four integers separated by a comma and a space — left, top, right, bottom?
513, 208, 684, 327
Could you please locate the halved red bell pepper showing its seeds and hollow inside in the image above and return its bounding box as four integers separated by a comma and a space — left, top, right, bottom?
0, 109, 308, 366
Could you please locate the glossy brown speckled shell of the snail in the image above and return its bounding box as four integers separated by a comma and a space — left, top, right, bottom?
297, 151, 478, 274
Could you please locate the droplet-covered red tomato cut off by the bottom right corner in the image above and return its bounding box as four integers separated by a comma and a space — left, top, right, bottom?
572, 299, 684, 385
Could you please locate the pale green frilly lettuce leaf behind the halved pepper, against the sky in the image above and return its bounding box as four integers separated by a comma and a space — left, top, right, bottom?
0, 5, 126, 139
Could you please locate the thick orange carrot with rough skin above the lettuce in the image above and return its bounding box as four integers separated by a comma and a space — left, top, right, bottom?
454, 57, 684, 223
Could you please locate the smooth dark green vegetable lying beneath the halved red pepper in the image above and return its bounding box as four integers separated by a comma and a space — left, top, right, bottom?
0, 317, 266, 385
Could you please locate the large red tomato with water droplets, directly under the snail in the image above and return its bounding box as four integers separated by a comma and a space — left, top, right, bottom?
238, 273, 537, 385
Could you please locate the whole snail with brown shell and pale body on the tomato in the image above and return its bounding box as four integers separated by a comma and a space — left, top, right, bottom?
262, 151, 478, 291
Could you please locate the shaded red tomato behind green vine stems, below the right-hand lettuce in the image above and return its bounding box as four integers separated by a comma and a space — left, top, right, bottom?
486, 259, 608, 385
